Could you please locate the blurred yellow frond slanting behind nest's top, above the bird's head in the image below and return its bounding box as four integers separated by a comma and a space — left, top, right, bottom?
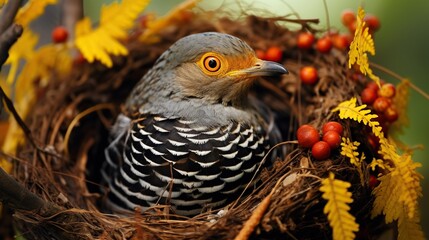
139, 0, 201, 43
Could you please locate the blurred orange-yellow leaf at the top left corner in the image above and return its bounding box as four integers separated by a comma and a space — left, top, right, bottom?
15, 0, 57, 27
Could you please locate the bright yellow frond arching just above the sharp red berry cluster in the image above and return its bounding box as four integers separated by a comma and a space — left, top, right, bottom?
332, 97, 383, 138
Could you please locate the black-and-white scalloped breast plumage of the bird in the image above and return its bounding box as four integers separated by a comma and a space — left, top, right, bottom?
104, 115, 269, 215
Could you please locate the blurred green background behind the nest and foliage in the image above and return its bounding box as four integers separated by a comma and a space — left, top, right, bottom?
85, 0, 429, 236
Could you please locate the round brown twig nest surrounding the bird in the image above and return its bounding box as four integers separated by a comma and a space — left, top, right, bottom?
7, 9, 382, 239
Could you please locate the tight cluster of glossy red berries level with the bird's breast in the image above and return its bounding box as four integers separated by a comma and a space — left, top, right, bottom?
297, 121, 343, 160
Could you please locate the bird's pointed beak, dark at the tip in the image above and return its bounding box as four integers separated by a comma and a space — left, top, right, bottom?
243, 59, 289, 77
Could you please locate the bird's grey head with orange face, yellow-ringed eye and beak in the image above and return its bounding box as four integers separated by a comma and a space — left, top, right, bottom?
127, 32, 287, 114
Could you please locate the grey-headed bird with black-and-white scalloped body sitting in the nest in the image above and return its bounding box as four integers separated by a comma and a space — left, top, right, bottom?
102, 32, 288, 216
